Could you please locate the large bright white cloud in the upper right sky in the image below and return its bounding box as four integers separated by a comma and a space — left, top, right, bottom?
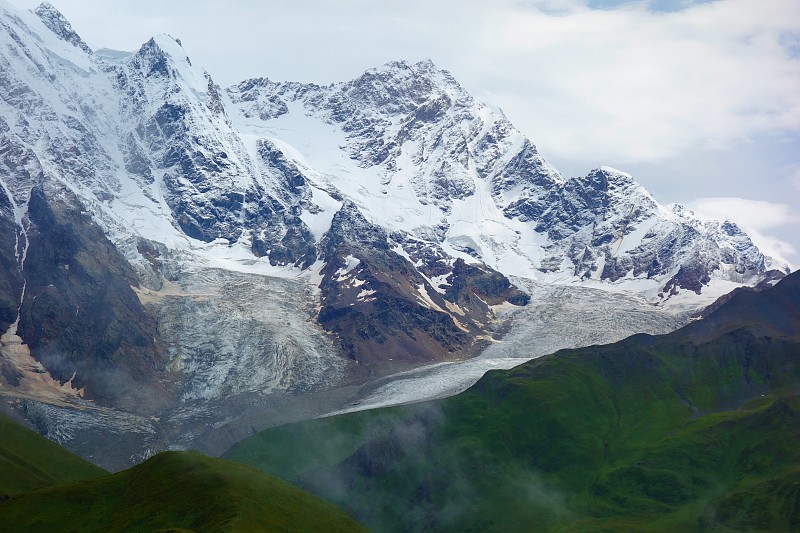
466, 0, 800, 163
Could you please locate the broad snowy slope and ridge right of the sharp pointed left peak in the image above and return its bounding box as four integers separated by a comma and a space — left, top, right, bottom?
222, 61, 785, 300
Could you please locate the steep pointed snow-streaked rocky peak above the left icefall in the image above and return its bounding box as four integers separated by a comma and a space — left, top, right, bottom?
112, 36, 314, 267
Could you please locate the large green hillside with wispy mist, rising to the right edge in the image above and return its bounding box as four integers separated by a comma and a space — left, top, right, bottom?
228, 274, 800, 532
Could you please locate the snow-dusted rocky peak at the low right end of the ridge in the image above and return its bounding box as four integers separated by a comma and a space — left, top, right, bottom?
505, 167, 770, 290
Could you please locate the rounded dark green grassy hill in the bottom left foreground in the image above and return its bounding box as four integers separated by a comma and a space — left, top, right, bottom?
0, 452, 363, 532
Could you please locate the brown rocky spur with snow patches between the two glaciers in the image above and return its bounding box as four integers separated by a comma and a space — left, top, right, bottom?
319, 201, 528, 364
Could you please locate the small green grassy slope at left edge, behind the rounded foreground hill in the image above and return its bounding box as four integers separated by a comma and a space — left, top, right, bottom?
0, 416, 108, 496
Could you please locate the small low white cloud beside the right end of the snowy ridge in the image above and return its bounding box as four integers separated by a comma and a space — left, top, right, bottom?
687, 198, 800, 265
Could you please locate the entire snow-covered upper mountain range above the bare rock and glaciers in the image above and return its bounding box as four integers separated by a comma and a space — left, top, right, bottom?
0, 5, 774, 304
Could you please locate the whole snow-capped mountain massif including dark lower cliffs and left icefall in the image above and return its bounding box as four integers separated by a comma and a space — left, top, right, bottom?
0, 0, 786, 466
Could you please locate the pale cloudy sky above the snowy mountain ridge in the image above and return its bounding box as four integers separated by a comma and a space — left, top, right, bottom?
11, 0, 800, 268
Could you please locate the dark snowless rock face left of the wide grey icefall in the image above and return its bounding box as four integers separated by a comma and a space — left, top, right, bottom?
18, 189, 172, 413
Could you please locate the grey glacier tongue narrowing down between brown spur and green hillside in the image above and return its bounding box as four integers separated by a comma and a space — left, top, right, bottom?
325, 279, 691, 416
